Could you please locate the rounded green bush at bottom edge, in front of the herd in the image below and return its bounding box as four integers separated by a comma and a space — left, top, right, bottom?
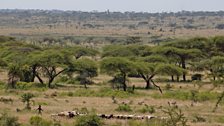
75, 114, 103, 126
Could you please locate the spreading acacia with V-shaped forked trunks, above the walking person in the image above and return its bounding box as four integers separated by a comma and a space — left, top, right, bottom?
33, 50, 70, 88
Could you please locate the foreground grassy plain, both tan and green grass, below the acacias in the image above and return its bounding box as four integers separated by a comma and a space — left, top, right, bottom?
0, 73, 224, 126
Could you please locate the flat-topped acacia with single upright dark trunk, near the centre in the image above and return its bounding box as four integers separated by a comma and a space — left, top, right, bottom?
100, 57, 134, 91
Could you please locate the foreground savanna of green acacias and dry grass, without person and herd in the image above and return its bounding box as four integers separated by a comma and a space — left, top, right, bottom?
0, 36, 224, 126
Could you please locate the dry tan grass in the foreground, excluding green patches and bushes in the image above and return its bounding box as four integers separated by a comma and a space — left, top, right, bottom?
0, 77, 224, 126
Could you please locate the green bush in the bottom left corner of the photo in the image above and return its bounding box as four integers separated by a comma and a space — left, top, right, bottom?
0, 113, 20, 126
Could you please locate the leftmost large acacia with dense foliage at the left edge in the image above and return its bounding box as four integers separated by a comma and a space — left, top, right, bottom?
0, 42, 39, 88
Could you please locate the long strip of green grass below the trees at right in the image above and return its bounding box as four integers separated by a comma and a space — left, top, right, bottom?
151, 90, 220, 102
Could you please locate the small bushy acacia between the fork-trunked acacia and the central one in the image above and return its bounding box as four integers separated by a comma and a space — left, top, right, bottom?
74, 58, 98, 88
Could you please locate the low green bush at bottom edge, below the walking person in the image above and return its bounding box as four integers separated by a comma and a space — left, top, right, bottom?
29, 116, 53, 126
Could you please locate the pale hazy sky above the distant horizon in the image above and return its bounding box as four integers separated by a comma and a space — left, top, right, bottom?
0, 0, 224, 12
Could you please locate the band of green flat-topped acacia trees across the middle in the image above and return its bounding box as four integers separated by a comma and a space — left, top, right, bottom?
0, 36, 224, 93
